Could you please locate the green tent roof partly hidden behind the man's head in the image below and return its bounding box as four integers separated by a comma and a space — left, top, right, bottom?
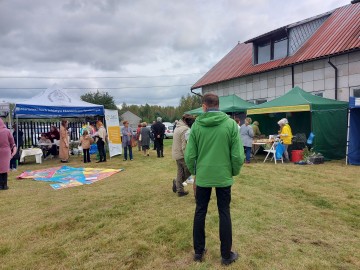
186, 95, 254, 114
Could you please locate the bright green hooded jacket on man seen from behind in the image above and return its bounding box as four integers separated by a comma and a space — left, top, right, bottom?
185, 111, 245, 187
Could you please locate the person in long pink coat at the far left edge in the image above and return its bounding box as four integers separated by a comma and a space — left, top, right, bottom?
0, 118, 17, 190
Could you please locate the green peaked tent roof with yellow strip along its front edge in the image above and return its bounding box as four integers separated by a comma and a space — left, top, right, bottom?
247, 86, 348, 115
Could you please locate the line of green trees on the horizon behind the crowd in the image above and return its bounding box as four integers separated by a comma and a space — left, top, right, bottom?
81, 90, 201, 123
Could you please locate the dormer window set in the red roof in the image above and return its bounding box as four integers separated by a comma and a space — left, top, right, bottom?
254, 36, 288, 65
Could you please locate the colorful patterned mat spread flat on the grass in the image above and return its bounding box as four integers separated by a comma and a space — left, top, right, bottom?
18, 166, 123, 189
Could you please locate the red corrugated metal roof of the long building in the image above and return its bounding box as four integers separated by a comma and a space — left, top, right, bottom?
191, 3, 360, 89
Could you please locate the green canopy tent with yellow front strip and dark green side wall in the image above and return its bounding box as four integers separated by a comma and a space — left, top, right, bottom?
247, 87, 348, 159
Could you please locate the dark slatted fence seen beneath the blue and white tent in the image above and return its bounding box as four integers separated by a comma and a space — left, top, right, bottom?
5, 121, 84, 148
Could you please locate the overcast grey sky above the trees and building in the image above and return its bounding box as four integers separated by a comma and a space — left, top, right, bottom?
0, 0, 351, 106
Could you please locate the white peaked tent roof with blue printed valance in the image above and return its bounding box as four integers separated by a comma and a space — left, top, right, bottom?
14, 85, 104, 118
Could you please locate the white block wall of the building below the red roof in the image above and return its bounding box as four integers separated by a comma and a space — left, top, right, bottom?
202, 51, 360, 101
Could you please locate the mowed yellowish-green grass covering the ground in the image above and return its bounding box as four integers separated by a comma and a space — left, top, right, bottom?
0, 140, 360, 270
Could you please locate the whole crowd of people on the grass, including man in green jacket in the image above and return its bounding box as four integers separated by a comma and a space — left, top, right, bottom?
0, 91, 292, 265
